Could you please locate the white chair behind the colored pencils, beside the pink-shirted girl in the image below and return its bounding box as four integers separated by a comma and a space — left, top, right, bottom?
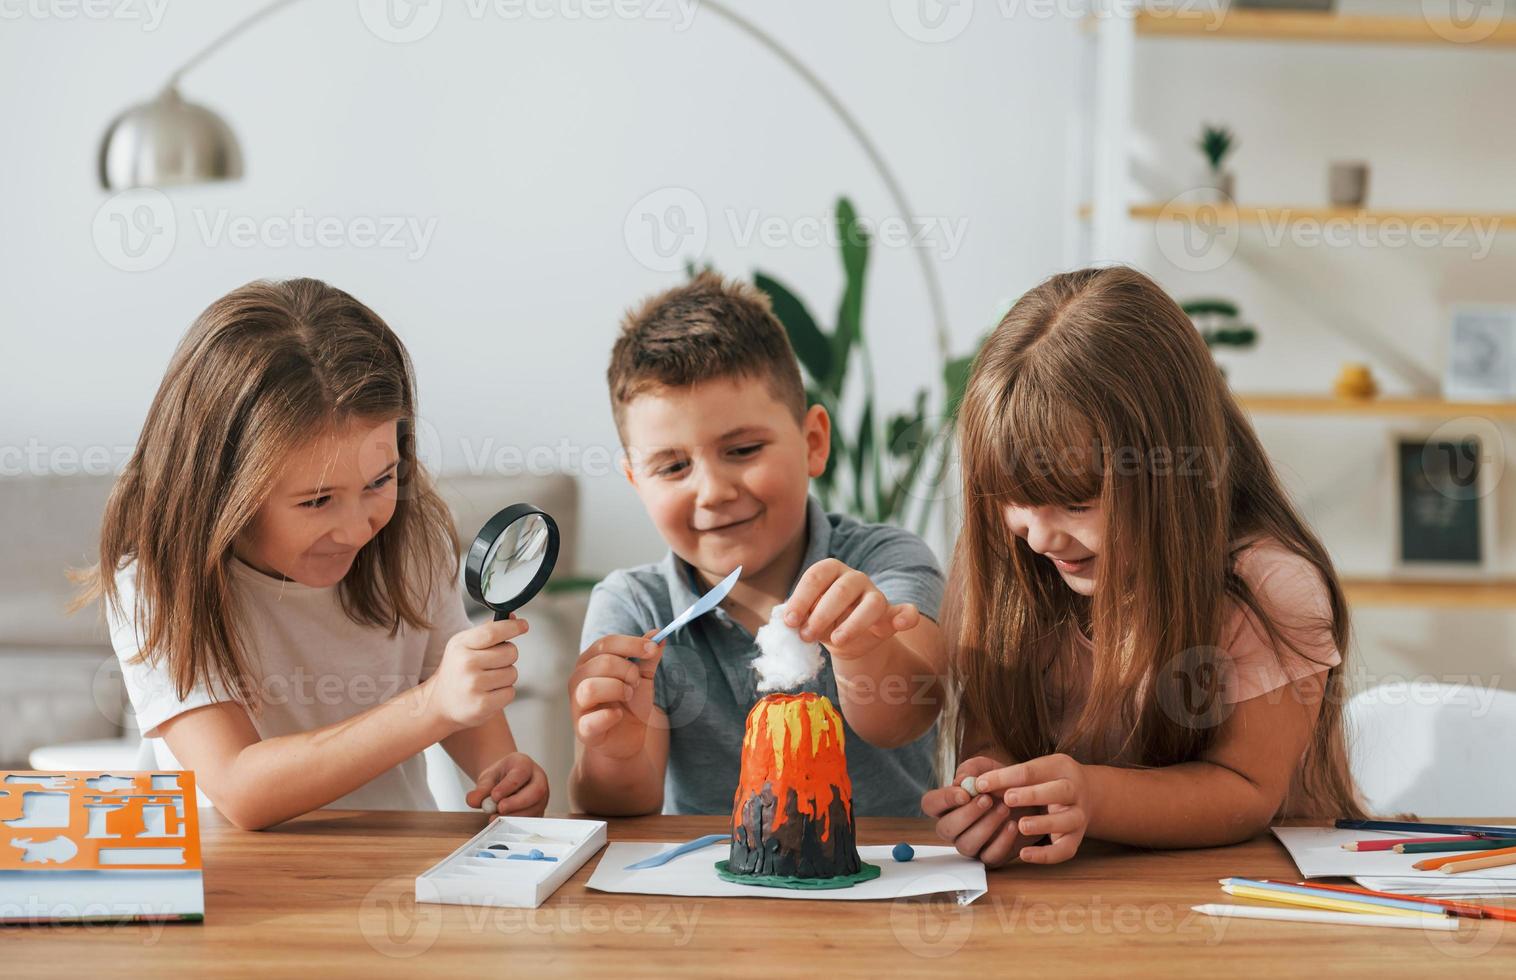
1348, 681, 1516, 818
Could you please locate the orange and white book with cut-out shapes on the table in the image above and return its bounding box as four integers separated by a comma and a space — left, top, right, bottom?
0, 771, 205, 924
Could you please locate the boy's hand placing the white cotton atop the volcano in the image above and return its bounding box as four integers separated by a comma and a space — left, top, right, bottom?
784, 558, 922, 660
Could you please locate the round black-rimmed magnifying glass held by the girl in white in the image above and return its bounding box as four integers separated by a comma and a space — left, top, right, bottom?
464, 504, 558, 622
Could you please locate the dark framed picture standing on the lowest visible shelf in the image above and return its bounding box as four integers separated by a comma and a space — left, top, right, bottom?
1390, 428, 1499, 578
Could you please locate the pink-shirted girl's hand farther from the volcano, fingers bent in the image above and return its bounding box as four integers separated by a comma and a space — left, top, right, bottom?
975, 754, 1090, 865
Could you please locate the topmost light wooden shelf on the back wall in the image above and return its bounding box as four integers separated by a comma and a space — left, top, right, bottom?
1135, 11, 1516, 49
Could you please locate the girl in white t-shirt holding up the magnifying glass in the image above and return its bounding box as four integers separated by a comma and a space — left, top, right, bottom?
80, 279, 547, 828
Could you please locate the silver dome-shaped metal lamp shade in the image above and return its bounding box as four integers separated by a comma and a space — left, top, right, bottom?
100, 86, 243, 191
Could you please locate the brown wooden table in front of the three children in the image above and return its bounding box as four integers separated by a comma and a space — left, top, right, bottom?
0, 810, 1516, 980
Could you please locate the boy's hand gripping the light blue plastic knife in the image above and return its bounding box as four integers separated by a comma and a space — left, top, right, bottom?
569, 630, 664, 759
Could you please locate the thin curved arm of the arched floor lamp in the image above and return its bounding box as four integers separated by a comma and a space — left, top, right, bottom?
144, 0, 952, 364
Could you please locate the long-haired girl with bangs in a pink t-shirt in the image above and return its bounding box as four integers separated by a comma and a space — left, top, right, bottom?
922, 267, 1361, 865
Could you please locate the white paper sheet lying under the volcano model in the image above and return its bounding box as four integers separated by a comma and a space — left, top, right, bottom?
588, 842, 988, 906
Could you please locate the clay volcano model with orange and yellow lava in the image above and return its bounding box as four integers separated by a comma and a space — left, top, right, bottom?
716, 693, 879, 889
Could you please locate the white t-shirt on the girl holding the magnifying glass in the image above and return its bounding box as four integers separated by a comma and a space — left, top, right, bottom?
106, 558, 470, 810
